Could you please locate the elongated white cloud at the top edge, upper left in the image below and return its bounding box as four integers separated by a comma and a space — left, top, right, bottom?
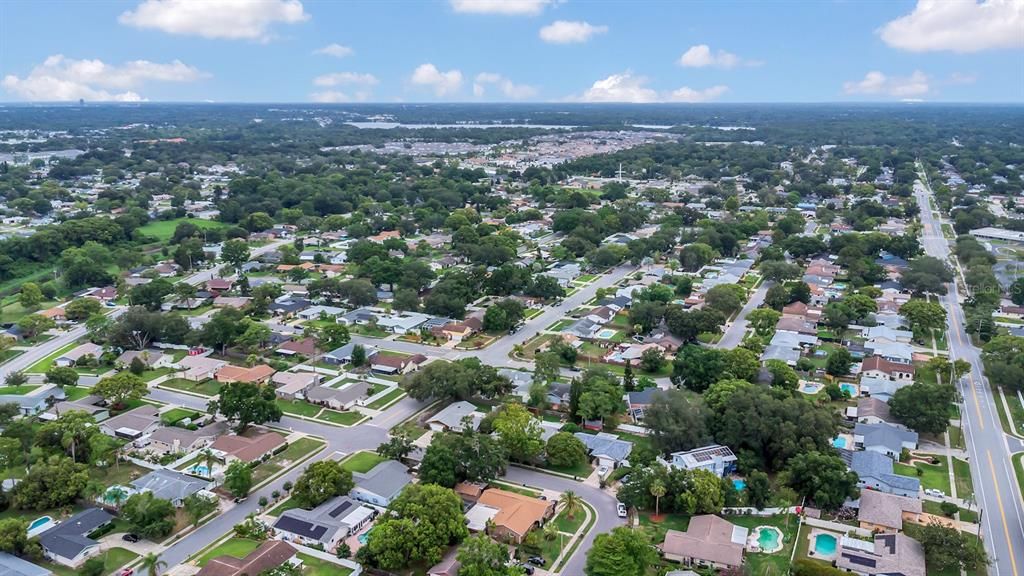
118, 0, 309, 41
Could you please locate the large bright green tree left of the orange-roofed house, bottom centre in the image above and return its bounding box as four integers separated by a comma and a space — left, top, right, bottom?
356, 484, 469, 571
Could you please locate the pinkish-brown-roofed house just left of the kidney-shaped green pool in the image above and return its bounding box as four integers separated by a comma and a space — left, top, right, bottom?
658, 515, 748, 569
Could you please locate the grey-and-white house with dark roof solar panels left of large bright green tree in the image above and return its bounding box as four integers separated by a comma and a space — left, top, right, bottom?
273, 496, 377, 550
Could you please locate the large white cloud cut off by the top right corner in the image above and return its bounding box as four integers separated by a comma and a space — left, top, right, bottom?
879, 0, 1024, 53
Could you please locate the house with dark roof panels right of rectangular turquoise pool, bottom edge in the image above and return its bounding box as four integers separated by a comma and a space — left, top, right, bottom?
836, 534, 927, 576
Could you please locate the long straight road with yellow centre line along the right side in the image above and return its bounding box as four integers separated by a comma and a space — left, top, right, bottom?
914, 171, 1024, 576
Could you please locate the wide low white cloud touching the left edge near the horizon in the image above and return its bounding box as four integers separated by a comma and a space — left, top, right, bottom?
2, 54, 209, 101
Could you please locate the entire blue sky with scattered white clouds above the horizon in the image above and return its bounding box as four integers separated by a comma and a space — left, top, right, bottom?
0, 0, 1024, 102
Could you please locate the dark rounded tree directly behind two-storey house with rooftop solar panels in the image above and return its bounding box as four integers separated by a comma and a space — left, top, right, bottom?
644, 390, 711, 454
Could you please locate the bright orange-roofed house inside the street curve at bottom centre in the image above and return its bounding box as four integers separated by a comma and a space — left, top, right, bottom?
466, 488, 555, 543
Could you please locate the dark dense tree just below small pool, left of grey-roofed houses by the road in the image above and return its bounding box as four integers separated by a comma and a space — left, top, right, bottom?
786, 451, 857, 510
